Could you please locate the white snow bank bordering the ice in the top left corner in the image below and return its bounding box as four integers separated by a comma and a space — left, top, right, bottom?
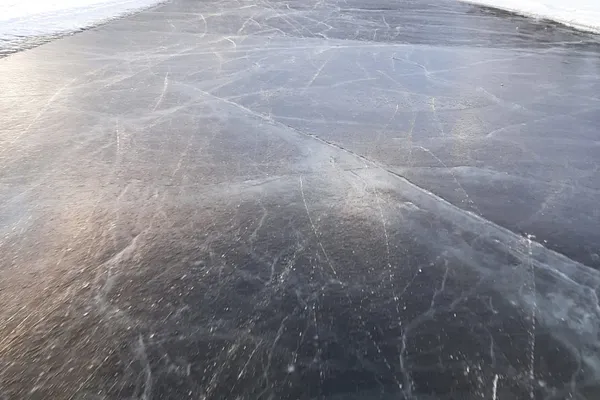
0, 0, 159, 55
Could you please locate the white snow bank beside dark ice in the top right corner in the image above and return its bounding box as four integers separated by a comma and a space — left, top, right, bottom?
460, 0, 600, 33
